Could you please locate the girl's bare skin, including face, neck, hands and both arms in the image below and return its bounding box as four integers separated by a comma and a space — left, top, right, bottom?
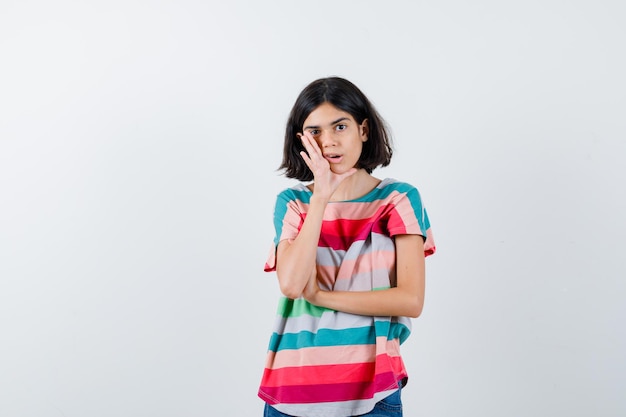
276, 103, 425, 317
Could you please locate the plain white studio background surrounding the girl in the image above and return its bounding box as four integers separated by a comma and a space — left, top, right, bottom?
0, 0, 626, 417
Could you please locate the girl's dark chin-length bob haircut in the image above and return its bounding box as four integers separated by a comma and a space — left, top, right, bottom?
278, 77, 393, 181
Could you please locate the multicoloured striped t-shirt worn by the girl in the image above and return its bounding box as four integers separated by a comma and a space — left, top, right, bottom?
259, 178, 435, 417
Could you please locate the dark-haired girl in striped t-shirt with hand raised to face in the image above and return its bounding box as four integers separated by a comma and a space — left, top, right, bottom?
259, 77, 435, 417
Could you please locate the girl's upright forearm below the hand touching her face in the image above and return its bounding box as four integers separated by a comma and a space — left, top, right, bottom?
276, 197, 328, 298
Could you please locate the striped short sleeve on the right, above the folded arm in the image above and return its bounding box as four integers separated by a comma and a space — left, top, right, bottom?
387, 186, 436, 256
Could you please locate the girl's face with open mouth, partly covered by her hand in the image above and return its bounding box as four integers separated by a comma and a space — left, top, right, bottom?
302, 102, 368, 174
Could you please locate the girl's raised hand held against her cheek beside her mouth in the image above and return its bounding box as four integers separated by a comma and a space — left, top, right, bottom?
298, 132, 357, 200
